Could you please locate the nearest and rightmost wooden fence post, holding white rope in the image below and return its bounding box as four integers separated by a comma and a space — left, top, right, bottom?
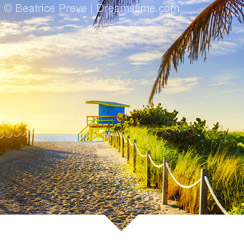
199, 169, 208, 214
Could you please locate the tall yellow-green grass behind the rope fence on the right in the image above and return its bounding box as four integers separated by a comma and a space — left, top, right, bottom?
125, 127, 244, 213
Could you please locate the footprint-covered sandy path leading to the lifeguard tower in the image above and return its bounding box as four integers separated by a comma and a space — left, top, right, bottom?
0, 142, 184, 229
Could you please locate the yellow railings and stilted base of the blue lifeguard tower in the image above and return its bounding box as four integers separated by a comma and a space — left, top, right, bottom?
78, 115, 115, 141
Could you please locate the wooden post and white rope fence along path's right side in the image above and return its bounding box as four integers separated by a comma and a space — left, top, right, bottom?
108, 132, 229, 215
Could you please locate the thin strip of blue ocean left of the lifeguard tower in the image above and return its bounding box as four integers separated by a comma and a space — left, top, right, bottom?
34, 134, 78, 141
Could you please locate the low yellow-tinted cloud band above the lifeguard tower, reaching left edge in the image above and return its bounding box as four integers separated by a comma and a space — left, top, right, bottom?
0, 62, 135, 94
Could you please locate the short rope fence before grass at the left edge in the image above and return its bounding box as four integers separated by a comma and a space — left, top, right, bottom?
0, 129, 35, 153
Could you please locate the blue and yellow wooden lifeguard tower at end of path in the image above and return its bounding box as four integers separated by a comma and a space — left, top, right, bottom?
78, 101, 130, 141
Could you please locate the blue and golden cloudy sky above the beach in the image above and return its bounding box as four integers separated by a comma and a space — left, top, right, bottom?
0, 0, 244, 134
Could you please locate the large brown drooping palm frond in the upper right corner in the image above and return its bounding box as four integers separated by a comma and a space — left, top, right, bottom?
149, 0, 244, 103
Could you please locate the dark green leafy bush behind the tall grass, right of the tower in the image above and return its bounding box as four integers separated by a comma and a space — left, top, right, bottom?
122, 103, 244, 155
